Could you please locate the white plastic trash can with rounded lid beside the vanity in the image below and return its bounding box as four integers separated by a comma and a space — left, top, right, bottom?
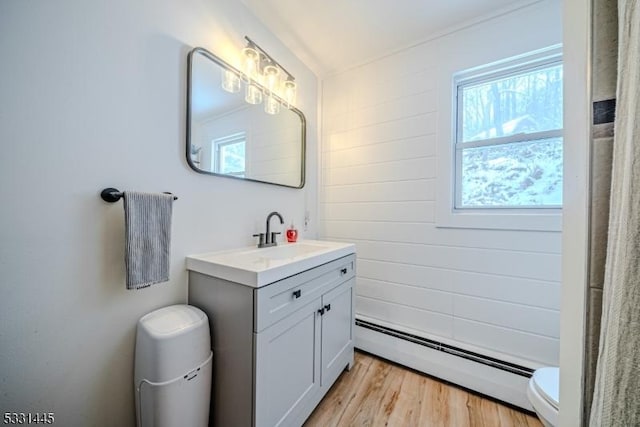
134, 304, 213, 427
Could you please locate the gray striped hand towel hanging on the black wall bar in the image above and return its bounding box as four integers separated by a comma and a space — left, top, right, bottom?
124, 191, 173, 289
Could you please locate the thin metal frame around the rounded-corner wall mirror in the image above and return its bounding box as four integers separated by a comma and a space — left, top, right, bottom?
185, 47, 307, 189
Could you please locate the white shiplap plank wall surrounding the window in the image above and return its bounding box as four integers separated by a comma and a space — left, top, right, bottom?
320, 0, 562, 372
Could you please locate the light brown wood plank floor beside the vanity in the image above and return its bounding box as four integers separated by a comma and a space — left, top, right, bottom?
305, 352, 542, 427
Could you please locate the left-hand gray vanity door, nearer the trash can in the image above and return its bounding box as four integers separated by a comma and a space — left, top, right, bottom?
254, 298, 320, 427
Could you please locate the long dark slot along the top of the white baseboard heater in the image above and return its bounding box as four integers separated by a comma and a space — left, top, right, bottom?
356, 319, 533, 378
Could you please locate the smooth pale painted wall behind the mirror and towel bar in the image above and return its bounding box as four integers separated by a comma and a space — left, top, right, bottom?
0, 0, 317, 426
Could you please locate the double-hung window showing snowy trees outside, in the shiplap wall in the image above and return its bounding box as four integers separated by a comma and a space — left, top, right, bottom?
454, 49, 563, 210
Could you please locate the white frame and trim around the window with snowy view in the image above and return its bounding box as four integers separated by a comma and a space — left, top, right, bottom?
436, 45, 562, 231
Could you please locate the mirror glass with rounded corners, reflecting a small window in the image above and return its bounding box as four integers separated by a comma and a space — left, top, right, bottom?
186, 48, 306, 188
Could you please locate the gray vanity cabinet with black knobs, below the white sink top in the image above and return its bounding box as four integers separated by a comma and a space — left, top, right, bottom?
189, 255, 355, 427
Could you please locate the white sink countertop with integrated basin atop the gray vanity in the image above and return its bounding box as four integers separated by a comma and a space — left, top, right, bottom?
187, 240, 355, 287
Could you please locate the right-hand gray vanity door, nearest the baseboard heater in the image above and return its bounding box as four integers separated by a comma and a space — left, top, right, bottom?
320, 279, 355, 387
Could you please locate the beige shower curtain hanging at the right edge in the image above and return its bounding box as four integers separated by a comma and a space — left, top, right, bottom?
589, 0, 640, 427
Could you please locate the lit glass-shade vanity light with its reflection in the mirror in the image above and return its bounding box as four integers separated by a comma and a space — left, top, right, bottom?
222, 36, 297, 114
